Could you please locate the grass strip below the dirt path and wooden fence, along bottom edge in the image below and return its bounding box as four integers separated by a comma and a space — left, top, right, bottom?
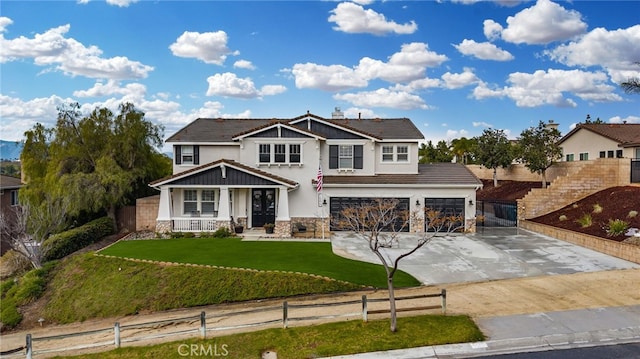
55, 315, 484, 359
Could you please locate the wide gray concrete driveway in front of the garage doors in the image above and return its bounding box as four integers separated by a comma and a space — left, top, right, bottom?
331, 228, 640, 285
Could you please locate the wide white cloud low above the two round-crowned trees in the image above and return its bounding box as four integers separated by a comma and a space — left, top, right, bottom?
473, 69, 622, 107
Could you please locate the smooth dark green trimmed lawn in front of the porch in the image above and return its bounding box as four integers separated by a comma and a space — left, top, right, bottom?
100, 238, 420, 288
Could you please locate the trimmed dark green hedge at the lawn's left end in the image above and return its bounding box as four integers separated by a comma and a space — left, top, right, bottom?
42, 217, 115, 262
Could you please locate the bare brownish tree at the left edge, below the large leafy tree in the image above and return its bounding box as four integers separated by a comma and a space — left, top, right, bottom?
0, 196, 68, 268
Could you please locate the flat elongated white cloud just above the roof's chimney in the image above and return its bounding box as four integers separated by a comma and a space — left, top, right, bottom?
333, 89, 428, 110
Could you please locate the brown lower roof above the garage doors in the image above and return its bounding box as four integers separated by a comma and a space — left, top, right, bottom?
323, 163, 482, 187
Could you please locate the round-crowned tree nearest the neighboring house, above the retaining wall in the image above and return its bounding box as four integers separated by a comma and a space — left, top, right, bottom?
518, 121, 562, 188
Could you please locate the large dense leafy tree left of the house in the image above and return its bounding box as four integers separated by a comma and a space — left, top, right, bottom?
20, 103, 171, 225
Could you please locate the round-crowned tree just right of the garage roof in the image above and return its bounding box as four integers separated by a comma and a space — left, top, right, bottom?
475, 128, 515, 187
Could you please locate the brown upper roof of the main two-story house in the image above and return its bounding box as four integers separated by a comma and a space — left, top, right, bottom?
166, 114, 424, 143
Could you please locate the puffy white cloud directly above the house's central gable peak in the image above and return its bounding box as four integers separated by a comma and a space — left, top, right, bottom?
291, 63, 368, 91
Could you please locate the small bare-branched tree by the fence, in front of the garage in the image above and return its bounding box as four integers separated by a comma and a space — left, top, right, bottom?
334, 199, 464, 332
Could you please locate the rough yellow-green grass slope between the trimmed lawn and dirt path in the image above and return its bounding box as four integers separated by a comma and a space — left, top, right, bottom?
43, 253, 361, 323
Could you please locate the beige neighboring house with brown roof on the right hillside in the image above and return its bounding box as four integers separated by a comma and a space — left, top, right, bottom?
559, 123, 640, 161
